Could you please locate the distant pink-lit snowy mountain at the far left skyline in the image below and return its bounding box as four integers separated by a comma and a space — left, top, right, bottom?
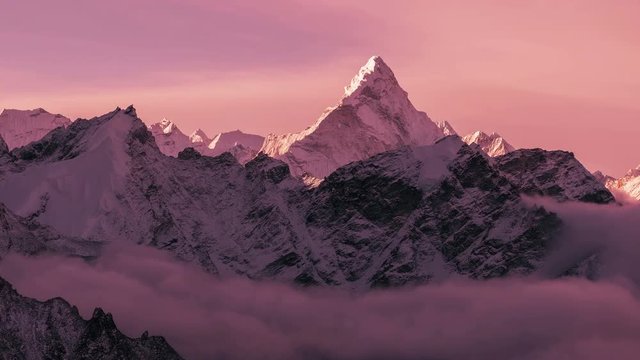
0, 109, 71, 150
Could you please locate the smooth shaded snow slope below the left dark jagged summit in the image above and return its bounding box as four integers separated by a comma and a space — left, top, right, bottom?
0, 108, 142, 237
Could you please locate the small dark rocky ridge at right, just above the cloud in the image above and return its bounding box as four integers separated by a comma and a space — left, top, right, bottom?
495, 149, 615, 204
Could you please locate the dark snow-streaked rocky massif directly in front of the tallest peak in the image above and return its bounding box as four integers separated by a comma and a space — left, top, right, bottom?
307, 138, 560, 287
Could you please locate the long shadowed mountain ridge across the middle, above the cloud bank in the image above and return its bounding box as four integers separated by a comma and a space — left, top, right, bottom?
0, 108, 610, 288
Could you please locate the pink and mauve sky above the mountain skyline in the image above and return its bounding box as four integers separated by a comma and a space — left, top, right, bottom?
0, 0, 640, 176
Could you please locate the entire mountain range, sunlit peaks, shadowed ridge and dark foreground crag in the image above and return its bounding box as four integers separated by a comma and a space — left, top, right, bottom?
0, 56, 640, 359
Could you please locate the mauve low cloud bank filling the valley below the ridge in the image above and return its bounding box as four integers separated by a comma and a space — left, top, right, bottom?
0, 204, 640, 360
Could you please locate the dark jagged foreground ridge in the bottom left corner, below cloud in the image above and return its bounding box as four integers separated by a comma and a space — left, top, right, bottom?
0, 278, 181, 360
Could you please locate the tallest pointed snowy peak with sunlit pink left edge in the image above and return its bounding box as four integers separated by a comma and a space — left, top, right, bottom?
261, 56, 444, 178
